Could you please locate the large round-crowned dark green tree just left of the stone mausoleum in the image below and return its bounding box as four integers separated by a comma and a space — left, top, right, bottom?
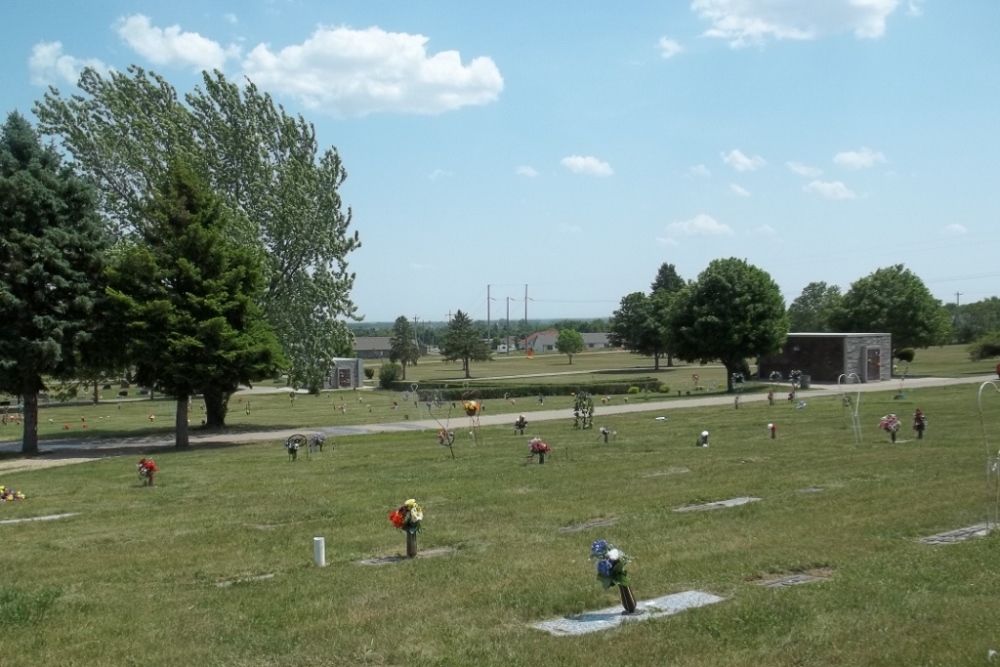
670, 258, 788, 391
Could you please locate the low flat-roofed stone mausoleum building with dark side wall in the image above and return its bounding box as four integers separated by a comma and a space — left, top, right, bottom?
757, 333, 892, 388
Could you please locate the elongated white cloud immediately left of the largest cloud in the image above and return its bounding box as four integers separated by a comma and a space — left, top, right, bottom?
116, 14, 240, 71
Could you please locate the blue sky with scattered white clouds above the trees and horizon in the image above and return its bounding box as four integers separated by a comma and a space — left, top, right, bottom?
0, 0, 1000, 321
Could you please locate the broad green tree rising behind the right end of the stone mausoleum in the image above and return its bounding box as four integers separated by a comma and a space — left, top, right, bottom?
832, 264, 951, 357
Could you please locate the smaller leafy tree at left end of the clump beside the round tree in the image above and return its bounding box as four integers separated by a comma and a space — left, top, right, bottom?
608, 290, 673, 370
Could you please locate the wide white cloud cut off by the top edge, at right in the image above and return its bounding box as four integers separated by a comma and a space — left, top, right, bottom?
691, 0, 914, 48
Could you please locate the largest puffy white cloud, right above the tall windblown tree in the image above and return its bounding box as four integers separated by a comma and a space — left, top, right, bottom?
243, 27, 503, 116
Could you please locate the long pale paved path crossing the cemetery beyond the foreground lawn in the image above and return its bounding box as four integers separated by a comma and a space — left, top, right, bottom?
0, 375, 1000, 474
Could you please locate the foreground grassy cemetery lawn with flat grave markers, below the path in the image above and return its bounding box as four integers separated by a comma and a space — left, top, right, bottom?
0, 380, 1000, 667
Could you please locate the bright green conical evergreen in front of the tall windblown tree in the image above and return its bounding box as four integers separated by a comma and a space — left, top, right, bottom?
109, 161, 281, 447
